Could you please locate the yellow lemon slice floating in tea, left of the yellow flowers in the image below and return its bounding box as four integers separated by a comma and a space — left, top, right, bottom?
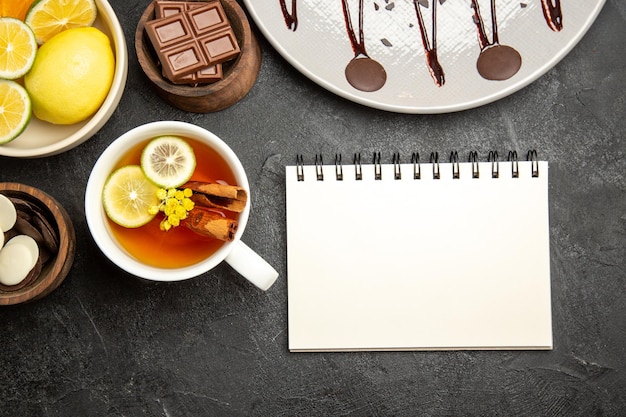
102, 165, 161, 228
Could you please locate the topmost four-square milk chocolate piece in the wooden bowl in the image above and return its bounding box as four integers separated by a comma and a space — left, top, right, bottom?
145, 1, 240, 81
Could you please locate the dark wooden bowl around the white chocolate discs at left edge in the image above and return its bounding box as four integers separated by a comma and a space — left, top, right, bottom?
0, 182, 76, 305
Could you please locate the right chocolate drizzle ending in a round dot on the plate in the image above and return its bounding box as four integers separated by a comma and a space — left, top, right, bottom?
472, 0, 522, 81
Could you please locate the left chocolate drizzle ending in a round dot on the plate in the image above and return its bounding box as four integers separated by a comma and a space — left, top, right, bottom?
341, 0, 387, 92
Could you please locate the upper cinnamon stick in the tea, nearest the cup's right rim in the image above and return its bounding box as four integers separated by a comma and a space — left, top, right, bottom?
183, 181, 248, 213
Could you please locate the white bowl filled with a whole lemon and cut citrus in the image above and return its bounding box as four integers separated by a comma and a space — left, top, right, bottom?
0, 0, 128, 158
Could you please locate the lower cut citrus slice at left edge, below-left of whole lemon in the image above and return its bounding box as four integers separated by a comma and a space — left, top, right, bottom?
0, 80, 31, 145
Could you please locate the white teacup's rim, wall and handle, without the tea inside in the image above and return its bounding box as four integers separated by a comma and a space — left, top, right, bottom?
85, 121, 278, 290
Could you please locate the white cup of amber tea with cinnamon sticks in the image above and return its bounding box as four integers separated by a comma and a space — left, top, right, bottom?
85, 121, 278, 290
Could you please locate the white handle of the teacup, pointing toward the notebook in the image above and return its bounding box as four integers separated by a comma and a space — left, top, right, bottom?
224, 240, 278, 291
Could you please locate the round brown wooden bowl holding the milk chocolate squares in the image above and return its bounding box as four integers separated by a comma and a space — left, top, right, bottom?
135, 0, 261, 113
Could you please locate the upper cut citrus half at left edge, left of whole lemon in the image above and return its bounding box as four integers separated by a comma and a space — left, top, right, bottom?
0, 17, 37, 80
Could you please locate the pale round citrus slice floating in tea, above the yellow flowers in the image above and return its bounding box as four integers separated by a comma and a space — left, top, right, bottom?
141, 136, 196, 188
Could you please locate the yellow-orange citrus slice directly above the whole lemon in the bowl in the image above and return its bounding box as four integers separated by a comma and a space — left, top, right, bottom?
25, 0, 98, 45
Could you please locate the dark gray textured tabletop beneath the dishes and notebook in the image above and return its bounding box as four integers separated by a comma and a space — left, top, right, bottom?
0, 0, 626, 417
